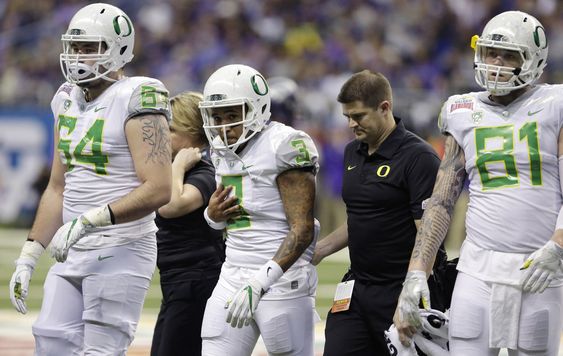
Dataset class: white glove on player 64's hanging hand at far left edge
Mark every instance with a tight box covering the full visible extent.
[10,241,45,314]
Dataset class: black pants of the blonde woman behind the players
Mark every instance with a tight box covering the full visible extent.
[151,266,220,356]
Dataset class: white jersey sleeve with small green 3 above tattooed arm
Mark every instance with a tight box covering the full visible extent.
[276,130,319,174]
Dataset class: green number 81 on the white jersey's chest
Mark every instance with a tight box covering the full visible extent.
[475,122,542,190]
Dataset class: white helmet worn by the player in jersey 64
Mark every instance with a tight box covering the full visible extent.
[60,3,135,84]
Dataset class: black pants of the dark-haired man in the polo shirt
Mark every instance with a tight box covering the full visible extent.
[324,277,402,356]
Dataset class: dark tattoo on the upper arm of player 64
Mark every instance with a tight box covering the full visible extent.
[141,115,171,165]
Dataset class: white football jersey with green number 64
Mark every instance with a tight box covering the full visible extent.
[51,77,170,248]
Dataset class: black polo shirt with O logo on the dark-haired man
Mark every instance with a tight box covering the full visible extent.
[342,118,440,284]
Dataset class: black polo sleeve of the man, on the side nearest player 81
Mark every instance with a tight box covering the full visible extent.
[407,152,440,219]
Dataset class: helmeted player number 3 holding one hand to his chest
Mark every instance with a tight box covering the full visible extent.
[200,64,318,356]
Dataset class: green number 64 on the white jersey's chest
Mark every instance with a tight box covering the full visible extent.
[58,115,109,175]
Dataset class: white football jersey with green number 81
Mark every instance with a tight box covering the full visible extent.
[440,85,563,253]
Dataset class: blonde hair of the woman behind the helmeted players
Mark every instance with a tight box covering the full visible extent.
[170,91,207,143]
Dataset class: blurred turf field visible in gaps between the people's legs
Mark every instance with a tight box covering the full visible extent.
[0,228,563,356]
